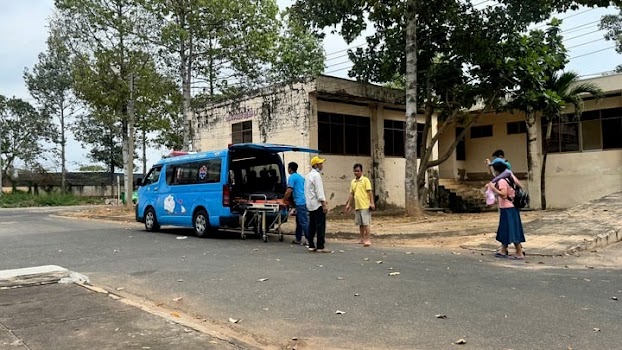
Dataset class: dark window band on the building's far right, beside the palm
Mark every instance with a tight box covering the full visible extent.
[542,108,622,153]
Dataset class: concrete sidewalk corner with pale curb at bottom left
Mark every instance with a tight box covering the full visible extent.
[0,266,263,350]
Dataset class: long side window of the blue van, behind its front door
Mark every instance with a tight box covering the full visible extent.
[166,159,222,186]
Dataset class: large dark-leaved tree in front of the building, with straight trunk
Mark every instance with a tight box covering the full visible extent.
[294,0,620,215]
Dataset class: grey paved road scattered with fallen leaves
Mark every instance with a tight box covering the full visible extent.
[0,209,622,349]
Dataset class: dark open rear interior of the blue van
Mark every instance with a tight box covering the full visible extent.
[229,151,286,199]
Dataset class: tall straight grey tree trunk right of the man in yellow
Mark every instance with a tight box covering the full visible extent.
[404,0,423,216]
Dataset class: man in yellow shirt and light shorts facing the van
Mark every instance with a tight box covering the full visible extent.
[346,163,376,247]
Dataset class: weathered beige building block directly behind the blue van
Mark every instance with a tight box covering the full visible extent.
[194,76,436,207]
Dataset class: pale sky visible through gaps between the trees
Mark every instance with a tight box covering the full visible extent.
[0,0,622,171]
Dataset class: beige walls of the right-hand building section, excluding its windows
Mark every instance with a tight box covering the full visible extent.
[439,74,622,208]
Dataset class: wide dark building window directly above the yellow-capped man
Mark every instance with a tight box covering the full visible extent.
[317,112,371,156]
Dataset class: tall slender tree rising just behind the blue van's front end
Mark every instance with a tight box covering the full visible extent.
[55,0,179,205]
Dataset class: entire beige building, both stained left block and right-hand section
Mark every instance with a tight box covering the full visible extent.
[194,74,622,208]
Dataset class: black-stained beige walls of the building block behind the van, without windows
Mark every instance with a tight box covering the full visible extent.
[194,77,438,208]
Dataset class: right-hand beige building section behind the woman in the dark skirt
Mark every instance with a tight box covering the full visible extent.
[439,74,622,208]
